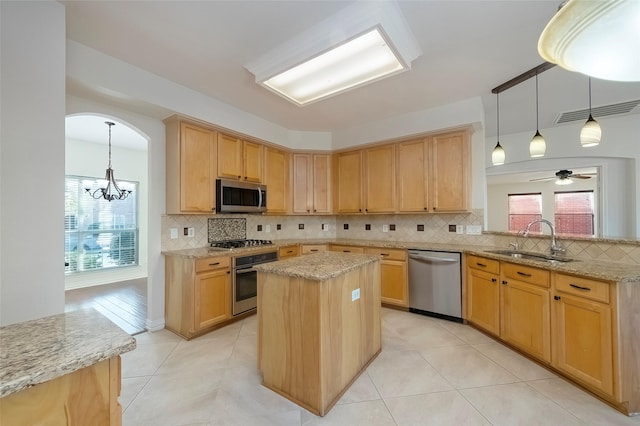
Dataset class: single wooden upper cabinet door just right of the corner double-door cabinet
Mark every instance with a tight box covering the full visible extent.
[333,149,364,213]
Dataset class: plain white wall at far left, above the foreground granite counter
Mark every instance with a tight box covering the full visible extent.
[0,1,65,325]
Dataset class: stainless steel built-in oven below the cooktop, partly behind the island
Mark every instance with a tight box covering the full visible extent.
[232,251,278,315]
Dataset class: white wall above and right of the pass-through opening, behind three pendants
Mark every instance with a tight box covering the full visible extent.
[485,114,640,238]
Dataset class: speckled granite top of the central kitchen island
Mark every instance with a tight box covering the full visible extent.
[254,252,380,281]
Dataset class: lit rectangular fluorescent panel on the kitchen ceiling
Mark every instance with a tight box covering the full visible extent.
[262,28,406,105]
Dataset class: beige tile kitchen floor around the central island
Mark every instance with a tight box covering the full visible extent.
[120,309,640,426]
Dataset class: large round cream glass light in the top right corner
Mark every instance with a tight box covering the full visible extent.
[538,0,640,81]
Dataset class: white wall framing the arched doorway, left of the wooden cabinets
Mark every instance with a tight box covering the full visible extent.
[67,96,165,330]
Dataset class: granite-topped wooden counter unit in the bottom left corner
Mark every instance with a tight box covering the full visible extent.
[0,309,136,425]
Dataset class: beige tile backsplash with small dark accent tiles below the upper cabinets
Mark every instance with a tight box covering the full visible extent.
[162,209,640,264]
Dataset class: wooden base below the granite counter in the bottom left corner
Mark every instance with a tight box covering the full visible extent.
[0,356,122,426]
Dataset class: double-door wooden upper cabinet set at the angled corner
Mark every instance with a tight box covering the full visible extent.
[290,154,331,214]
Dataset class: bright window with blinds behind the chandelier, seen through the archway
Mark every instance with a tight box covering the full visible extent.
[64,176,138,274]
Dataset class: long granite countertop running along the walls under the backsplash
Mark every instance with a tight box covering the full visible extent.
[164,239,640,283]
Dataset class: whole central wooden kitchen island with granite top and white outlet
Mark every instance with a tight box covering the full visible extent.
[255,252,381,416]
